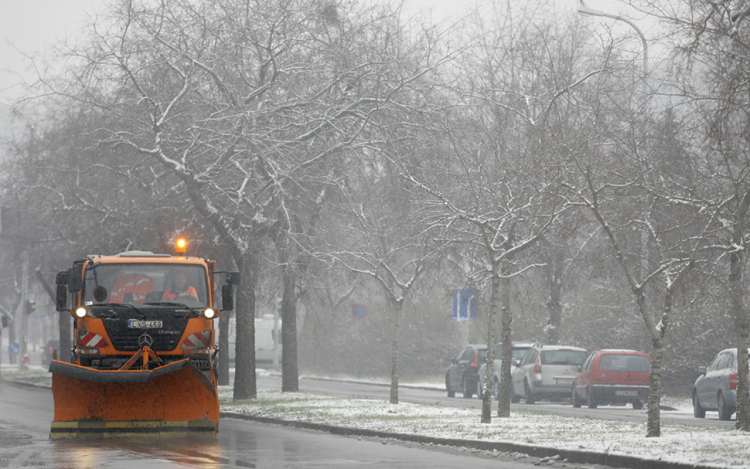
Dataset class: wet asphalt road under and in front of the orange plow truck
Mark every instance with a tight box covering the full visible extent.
[0,382,575,469]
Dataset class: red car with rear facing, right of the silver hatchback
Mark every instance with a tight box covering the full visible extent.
[571,350,651,409]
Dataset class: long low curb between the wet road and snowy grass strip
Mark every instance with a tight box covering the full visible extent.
[220,412,719,469]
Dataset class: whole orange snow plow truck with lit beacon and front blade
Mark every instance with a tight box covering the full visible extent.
[49,240,239,439]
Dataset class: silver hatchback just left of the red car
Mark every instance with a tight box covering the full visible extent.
[511,345,588,404]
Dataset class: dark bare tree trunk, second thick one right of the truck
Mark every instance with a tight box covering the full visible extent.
[281,264,299,392]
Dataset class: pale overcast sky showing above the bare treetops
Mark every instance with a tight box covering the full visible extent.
[0,0,624,103]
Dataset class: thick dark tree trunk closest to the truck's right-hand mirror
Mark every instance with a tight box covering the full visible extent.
[233,254,258,400]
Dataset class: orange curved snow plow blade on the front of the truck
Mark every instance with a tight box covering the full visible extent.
[50,359,219,439]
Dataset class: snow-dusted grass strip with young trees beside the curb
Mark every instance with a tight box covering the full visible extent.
[219,386,750,469]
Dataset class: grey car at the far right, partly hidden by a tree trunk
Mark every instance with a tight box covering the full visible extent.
[693,348,750,420]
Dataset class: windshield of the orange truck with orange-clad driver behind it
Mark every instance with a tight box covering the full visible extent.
[82,263,208,307]
